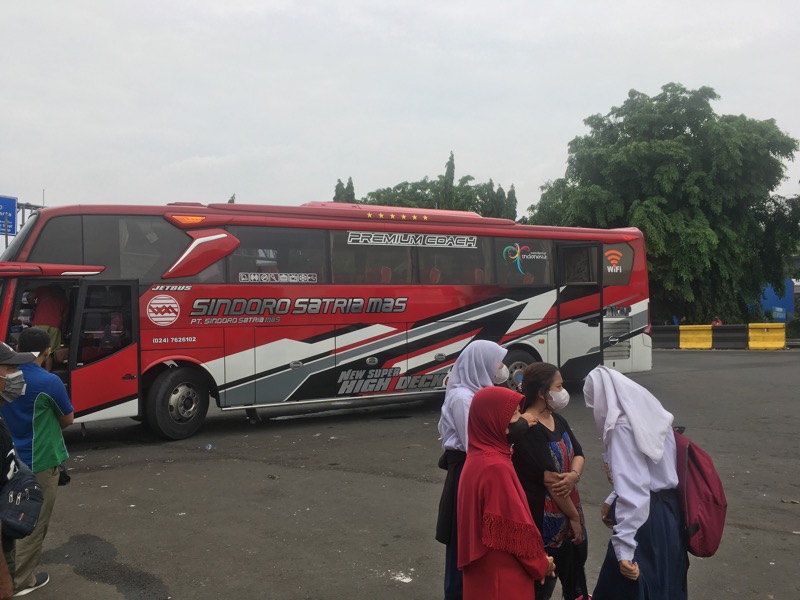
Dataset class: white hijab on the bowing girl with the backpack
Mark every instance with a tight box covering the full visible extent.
[583,366,673,463]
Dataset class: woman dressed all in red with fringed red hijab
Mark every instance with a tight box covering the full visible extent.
[458,387,553,600]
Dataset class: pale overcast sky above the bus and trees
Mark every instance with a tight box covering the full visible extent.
[0,0,800,215]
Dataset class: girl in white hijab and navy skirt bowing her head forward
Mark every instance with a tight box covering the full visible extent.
[583,367,689,600]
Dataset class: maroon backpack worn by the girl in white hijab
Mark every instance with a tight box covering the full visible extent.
[675,431,728,557]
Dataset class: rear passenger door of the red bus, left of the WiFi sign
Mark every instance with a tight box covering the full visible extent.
[548,241,603,381]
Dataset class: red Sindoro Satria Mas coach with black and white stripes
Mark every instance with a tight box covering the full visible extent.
[0,202,652,439]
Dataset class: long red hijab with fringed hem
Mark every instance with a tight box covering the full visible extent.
[458,387,547,577]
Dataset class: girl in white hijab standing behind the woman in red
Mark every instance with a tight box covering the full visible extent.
[436,340,508,600]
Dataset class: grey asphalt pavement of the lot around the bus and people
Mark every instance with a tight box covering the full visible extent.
[29,350,800,600]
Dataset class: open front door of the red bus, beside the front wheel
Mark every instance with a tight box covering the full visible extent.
[69,280,139,422]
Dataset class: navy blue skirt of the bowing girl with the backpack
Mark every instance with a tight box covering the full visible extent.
[592,490,689,600]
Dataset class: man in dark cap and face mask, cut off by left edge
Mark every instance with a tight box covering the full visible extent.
[0,342,36,600]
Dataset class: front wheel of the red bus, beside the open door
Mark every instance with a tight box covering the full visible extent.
[145,368,209,440]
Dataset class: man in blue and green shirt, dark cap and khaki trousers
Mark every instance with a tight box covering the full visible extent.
[0,327,73,596]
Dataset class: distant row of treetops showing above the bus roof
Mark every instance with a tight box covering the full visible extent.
[333,152,517,220]
